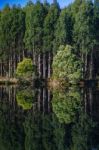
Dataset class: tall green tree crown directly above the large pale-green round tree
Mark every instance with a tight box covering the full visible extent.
[54,8,73,53]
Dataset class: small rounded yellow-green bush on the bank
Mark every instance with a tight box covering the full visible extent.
[16,58,35,79]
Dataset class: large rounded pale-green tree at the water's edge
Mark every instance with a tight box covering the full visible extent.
[52,45,82,83]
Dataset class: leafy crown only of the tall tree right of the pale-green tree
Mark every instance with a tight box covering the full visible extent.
[74,1,95,53]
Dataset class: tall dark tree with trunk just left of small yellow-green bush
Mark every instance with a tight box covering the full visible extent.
[10,6,25,75]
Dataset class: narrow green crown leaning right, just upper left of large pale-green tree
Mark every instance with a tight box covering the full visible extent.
[43,3,60,52]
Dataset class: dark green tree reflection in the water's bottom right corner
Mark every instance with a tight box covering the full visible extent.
[71,113,96,150]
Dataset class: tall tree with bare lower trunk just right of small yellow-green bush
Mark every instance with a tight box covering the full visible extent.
[24,1,46,77]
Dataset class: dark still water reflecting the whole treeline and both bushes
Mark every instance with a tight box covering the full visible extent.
[0,86,99,150]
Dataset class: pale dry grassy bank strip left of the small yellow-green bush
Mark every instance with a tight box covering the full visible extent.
[0,77,18,84]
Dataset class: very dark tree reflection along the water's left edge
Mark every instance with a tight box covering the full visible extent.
[0,87,24,150]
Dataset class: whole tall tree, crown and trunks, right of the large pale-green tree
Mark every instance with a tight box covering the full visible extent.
[74,0,95,78]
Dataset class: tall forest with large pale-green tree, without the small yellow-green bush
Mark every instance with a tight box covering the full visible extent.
[0,0,99,81]
